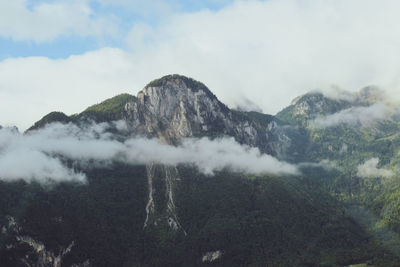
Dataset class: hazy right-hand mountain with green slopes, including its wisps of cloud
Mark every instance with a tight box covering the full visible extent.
[277,87,400,264]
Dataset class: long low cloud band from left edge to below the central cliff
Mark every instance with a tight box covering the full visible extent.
[0,122,297,182]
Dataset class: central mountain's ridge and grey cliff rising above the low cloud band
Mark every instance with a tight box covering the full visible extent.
[28,75,286,155]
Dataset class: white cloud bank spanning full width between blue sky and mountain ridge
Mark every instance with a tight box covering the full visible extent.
[0,0,400,128]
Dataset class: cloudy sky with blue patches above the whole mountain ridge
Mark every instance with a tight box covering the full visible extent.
[0,0,400,130]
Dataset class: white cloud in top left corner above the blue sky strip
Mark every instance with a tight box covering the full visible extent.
[0,0,115,42]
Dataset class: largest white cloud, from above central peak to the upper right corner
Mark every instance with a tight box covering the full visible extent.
[124,0,400,113]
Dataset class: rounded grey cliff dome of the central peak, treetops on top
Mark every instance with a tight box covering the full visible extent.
[126,75,231,141]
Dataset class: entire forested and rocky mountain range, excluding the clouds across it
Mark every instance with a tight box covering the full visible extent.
[0,75,400,266]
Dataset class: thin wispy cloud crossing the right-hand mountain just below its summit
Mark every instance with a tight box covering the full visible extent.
[311,103,391,128]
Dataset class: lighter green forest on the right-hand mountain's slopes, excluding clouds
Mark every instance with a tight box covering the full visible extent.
[279,93,400,266]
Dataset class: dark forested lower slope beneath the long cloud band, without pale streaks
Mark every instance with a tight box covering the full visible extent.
[0,164,391,266]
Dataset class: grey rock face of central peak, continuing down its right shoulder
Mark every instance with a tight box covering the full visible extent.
[125,75,284,154]
